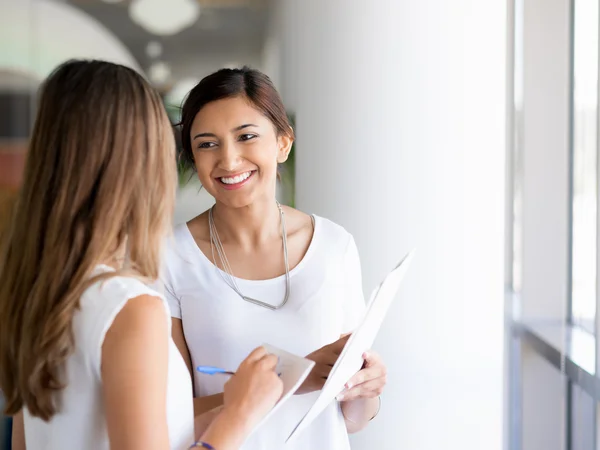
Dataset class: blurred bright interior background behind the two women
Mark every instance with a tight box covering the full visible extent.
[0,0,600,450]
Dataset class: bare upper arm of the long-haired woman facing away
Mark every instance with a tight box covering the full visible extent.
[101,295,169,450]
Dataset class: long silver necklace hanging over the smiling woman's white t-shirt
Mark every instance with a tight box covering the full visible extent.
[208,202,291,311]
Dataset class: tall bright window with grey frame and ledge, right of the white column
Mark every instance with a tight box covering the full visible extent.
[507,0,600,450]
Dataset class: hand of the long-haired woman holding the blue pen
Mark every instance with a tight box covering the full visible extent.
[223,347,283,429]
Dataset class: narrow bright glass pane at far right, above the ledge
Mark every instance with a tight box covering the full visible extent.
[571,0,598,331]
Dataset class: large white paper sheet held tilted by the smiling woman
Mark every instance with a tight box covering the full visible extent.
[287,251,414,442]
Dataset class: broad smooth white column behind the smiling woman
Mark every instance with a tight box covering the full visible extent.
[280,0,506,450]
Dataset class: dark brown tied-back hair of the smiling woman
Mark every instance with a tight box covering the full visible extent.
[179,66,294,168]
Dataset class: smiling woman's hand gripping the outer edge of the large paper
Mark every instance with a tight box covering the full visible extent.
[337,350,387,402]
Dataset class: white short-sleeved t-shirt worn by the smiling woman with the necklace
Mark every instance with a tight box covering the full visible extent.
[164,217,365,450]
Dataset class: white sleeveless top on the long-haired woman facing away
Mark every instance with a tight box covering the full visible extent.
[24,266,194,450]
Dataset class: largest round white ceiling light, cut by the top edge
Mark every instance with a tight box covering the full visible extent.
[129,0,200,36]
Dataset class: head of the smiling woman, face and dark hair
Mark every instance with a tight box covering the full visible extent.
[181,68,294,206]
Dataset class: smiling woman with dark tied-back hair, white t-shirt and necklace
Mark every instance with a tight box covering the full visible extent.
[164,68,386,450]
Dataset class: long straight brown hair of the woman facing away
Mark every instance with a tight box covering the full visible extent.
[0,61,176,420]
